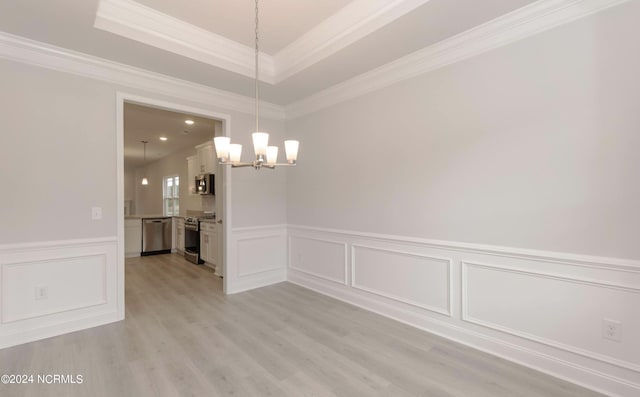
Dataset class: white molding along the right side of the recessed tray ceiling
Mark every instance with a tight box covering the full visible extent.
[274,0,430,82]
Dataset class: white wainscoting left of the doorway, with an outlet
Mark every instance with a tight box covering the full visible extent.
[0,237,124,348]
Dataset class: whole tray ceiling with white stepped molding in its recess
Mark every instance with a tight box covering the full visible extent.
[0,0,556,105]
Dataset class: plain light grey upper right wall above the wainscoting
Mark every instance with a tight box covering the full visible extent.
[287,2,640,259]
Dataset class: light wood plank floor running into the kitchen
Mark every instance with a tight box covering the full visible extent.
[0,255,599,397]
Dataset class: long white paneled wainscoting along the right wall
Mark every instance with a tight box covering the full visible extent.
[287,226,640,396]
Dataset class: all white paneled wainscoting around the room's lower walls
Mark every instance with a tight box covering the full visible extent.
[0,225,640,396]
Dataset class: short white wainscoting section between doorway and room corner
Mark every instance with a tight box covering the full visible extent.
[225,225,287,294]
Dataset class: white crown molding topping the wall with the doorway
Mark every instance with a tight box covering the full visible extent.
[0,32,285,120]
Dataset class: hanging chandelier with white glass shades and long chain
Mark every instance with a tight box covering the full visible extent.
[213,0,299,170]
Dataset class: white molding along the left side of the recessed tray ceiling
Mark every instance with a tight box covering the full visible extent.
[93,0,275,84]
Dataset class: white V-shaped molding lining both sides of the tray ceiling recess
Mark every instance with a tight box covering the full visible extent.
[93,0,430,84]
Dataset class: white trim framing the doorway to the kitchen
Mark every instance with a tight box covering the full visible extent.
[116,91,232,319]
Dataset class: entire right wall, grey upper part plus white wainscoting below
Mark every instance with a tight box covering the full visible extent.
[287,2,640,396]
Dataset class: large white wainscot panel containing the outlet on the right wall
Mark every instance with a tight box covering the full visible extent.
[462,262,640,372]
